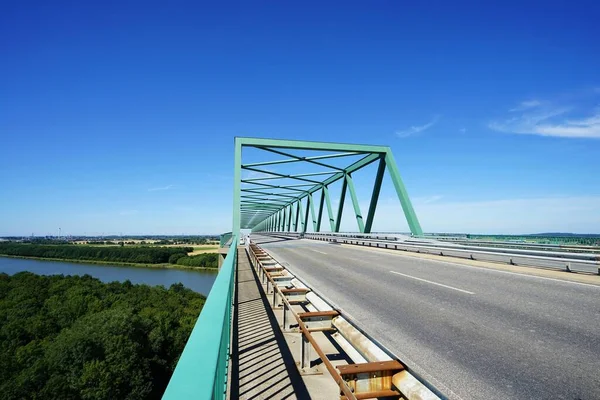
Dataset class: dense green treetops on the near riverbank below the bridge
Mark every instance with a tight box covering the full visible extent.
[0,272,205,399]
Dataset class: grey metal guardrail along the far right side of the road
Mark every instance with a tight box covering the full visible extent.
[304,233,600,274]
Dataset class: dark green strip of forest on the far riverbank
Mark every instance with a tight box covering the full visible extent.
[0,242,194,264]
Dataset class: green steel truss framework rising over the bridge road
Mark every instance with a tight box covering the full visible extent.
[233,137,423,236]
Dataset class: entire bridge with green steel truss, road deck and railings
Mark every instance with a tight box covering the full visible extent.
[163,138,600,400]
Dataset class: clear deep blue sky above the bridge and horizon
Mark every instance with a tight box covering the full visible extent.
[0,1,600,235]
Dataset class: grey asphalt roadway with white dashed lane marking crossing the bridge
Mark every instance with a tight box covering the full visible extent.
[252,235,600,400]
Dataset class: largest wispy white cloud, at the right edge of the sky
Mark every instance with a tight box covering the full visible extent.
[488,100,600,139]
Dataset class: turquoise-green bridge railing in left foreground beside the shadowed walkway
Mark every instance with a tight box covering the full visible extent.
[163,236,239,400]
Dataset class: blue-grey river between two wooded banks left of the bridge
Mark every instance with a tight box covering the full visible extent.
[0,256,217,296]
